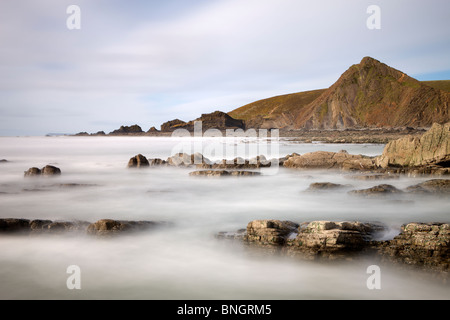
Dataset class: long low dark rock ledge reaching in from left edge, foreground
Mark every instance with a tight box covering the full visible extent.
[0,218,168,236]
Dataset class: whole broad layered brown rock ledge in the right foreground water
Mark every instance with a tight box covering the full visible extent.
[217,220,450,275]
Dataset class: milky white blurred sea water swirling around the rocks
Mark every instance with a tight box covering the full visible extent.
[0,137,450,299]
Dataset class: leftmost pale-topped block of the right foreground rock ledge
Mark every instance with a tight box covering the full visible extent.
[244,220,299,245]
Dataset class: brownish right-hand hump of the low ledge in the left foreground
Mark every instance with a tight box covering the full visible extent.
[87,219,161,236]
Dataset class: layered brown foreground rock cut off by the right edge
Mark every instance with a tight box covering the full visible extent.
[382,223,450,271]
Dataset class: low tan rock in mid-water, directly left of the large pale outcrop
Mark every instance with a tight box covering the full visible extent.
[283,151,375,170]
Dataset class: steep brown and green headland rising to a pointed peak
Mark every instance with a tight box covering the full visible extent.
[229,57,450,129]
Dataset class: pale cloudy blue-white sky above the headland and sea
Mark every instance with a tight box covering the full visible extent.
[0,0,450,135]
